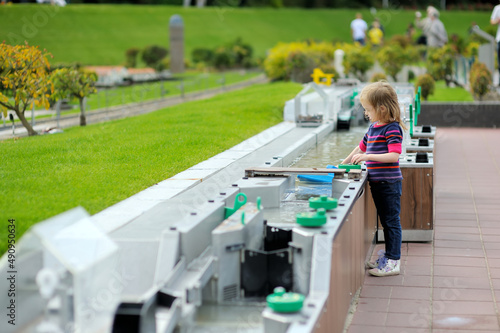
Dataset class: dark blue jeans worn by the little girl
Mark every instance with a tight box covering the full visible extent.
[370,181,403,260]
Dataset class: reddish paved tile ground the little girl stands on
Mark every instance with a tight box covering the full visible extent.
[348,128,500,333]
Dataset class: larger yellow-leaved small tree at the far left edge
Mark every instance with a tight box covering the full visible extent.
[0,42,54,136]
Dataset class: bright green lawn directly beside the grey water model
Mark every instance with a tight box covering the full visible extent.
[0,83,301,253]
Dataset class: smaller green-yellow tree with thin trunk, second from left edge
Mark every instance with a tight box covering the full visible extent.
[52,68,97,126]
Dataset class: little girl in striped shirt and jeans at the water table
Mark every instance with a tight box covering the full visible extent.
[342,82,405,276]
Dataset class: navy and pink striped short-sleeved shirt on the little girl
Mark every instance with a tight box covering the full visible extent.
[359,122,403,182]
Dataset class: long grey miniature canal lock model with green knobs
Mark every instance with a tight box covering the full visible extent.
[0,81,432,333]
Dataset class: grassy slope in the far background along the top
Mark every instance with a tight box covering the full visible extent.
[0,5,491,65]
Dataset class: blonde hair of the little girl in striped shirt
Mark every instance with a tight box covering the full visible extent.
[359,81,406,130]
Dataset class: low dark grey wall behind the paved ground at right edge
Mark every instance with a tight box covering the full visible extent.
[418,102,500,128]
